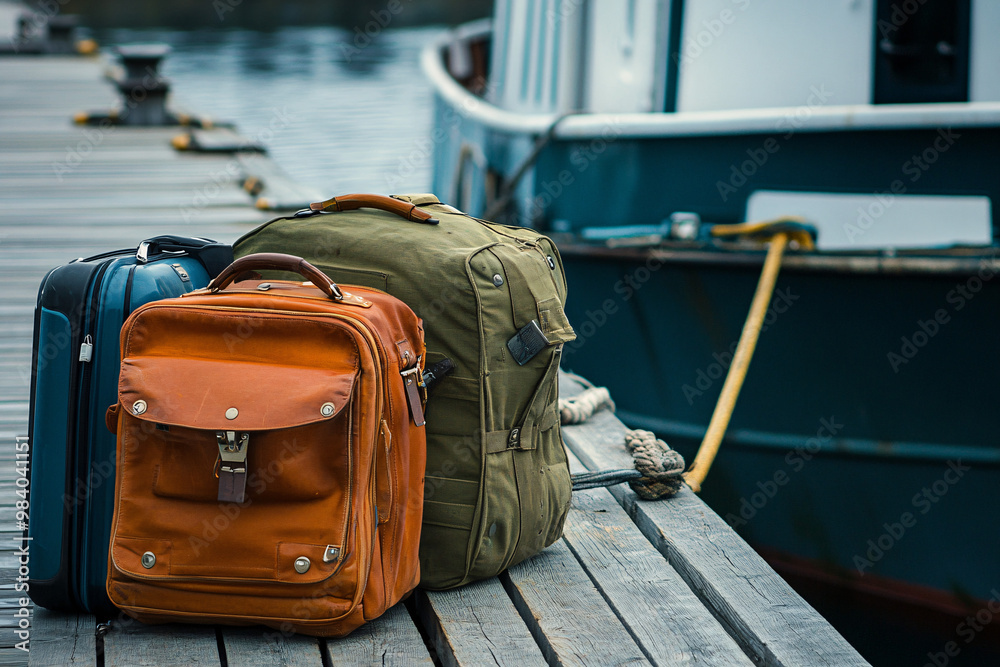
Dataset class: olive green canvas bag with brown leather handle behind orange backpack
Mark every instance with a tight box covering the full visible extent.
[234,195,575,589]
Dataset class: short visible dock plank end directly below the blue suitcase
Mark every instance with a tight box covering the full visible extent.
[27,607,97,667]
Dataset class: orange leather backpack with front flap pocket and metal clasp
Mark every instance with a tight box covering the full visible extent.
[108,254,426,636]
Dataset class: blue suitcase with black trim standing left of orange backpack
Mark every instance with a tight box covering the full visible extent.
[27,236,233,615]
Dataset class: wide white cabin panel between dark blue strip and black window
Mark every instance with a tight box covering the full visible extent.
[677,0,875,111]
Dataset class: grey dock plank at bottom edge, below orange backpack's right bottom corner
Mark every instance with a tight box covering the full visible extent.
[325,604,433,666]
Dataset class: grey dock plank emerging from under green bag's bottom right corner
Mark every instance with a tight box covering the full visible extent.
[500,540,650,665]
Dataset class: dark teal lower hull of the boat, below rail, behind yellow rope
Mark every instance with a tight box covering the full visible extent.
[563,246,1000,611]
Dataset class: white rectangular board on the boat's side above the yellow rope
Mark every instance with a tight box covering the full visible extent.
[746,190,992,250]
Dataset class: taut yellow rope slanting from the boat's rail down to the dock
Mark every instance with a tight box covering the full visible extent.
[684,229,792,493]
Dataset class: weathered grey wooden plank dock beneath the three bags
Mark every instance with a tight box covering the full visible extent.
[0,47,866,667]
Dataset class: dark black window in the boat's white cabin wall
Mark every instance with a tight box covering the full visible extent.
[873,0,970,104]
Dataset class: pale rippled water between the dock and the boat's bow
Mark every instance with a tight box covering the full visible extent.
[99,27,443,196]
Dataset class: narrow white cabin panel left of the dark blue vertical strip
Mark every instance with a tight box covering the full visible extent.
[584,0,668,113]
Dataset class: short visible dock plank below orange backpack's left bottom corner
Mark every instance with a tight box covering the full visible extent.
[104,617,222,667]
